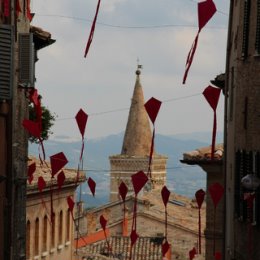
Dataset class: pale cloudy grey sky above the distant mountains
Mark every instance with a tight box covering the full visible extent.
[31,0,229,140]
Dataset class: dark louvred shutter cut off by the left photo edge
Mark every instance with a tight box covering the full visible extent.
[0,25,13,100]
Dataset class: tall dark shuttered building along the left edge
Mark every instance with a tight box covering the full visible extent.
[0,0,39,260]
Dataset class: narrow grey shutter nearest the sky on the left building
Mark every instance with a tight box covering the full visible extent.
[19,33,35,87]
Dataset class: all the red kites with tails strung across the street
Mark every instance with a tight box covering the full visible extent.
[22,0,224,260]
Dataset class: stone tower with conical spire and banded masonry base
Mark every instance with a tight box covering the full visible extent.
[109,66,167,201]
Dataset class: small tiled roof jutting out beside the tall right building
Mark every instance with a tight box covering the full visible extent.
[181,144,224,164]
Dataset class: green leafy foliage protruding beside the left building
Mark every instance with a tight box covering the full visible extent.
[29,104,57,143]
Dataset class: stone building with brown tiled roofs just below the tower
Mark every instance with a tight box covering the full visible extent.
[78,190,206,260]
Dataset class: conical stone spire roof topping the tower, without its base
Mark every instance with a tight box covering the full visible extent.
[121,69,152,156]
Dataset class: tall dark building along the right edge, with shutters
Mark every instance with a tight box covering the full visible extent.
[225,0,260,260]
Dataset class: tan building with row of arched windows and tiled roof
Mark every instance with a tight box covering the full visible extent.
[26,157,85,260]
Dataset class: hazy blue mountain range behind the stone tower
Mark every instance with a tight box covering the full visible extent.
[29,132,223,207]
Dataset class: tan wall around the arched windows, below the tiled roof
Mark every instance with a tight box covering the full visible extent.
[26,189,74,260]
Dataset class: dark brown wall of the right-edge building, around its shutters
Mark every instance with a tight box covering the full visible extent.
[225,1,260,260]
